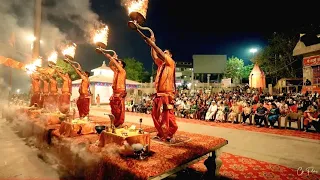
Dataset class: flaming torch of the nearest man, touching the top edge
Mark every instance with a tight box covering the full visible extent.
[125,0,154,39]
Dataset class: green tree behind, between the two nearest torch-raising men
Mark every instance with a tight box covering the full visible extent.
[123,58,150,82]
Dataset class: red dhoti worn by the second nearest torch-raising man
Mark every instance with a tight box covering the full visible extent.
[110,92,126,127]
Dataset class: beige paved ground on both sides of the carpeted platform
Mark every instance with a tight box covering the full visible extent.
[0,107,320,180]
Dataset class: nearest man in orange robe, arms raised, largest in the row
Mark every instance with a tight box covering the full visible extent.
[145,37,178,142]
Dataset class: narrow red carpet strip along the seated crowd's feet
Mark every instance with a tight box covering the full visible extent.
[126,112,320,140]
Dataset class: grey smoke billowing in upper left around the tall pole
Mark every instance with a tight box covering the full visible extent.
[0,0,99,92]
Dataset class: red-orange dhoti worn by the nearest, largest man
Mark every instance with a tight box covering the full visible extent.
[151,96,178,139]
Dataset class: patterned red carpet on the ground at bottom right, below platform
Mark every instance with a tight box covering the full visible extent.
[190,153,320,180]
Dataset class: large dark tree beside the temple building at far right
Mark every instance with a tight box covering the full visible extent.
[252,33,302,82]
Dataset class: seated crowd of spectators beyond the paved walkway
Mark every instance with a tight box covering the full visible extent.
[126,88,320,132]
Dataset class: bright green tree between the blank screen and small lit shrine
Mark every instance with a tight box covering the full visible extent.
[224,56,253,80]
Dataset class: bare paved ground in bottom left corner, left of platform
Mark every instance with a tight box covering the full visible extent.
[0,118,59,180]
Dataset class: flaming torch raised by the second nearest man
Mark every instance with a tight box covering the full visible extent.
[93,25,117,57]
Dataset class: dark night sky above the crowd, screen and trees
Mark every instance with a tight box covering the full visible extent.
[77,0,315,70]
